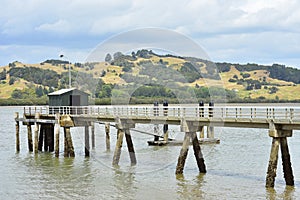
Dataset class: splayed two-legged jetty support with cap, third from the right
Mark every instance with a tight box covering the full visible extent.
[112,119,136,165]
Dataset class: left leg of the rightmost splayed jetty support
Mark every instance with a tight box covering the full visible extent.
[266,137,280,187]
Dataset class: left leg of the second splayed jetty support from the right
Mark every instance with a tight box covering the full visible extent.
[175,132,191,174]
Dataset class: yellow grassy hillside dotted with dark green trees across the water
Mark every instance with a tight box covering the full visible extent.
[0,50,300,105]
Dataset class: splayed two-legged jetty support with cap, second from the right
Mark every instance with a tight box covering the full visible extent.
[176,120,206,174]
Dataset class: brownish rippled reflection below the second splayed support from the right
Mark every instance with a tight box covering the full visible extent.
[176,173,205,199]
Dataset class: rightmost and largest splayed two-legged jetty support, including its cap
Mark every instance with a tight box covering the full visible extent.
[266,120,294,187]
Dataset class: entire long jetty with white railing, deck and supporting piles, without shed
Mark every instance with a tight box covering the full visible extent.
[15,106,300,187]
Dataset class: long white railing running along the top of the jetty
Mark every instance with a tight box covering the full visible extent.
[24,106,300,120]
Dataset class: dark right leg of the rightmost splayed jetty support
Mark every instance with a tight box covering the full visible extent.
[280,137,294,186]
